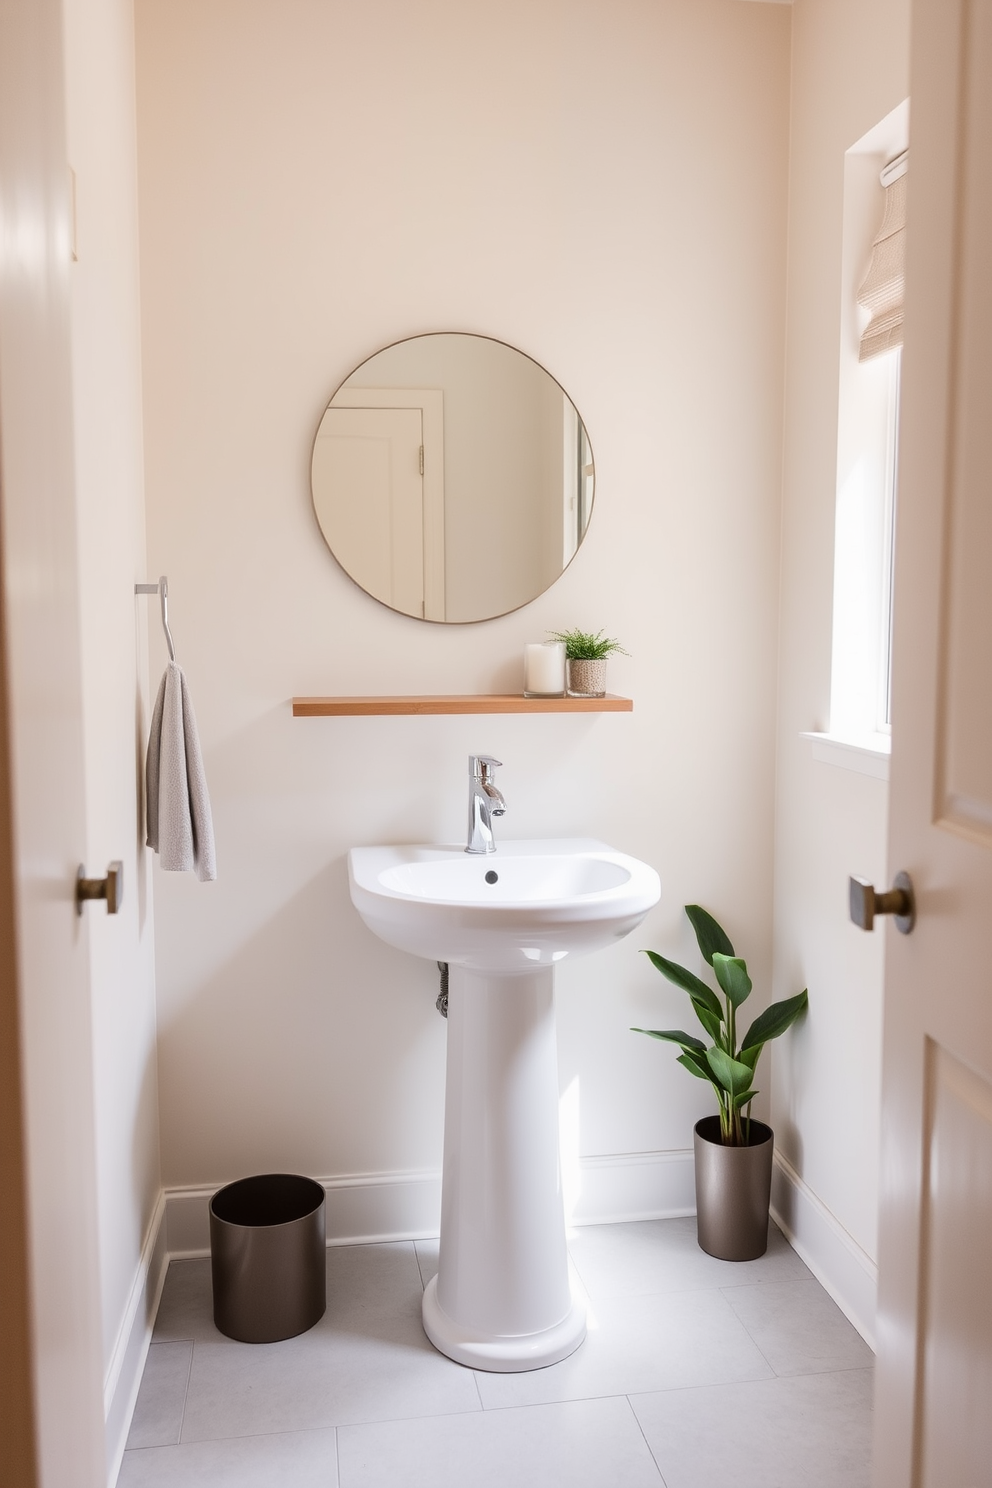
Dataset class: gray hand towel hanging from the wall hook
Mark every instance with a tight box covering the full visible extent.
[144,661,217,882]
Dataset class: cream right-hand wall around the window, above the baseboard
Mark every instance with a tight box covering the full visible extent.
[772,0,909,1335]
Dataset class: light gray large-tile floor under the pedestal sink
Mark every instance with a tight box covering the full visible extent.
[117,1219,872,1488]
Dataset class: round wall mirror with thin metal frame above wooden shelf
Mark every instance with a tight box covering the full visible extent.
[311,333,595,623]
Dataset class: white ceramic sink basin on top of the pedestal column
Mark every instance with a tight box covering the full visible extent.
[348,838,660,973]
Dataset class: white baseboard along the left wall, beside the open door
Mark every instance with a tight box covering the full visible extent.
[103,1193,170,1488]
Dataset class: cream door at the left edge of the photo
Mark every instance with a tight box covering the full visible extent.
[0,0,106,1488]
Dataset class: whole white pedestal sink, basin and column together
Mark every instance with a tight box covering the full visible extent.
[348,838,660,1373]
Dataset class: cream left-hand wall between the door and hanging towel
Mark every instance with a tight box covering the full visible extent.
[64,0,161,1460]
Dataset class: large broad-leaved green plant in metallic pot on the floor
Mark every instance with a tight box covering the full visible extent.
[631,905,809,1260]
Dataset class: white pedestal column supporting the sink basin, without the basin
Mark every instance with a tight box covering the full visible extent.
[424,966,586,1373]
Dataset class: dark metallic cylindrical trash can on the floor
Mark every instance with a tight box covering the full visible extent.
[210,1173,327,1344]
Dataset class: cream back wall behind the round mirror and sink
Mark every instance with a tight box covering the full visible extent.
[137,0,791,1223]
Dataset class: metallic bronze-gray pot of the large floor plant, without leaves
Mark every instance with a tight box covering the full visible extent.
[693,1116,775,1260]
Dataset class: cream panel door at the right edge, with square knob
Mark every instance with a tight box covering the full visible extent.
[875,0,992,1488]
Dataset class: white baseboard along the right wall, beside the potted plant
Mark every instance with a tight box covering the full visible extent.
[772,1152,879,1348]
